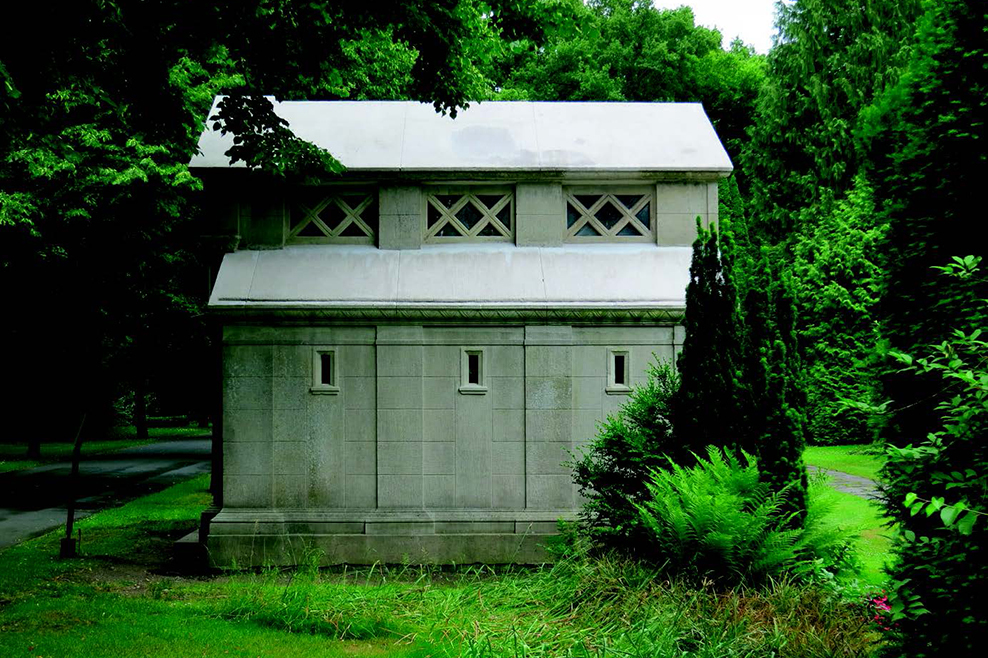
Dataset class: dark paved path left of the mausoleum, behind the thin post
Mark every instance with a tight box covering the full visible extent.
[0,437,211,548]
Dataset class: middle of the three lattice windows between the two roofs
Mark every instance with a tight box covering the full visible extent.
[425,190,515,242]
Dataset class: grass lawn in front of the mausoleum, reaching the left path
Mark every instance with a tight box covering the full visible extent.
[0,477,877,658]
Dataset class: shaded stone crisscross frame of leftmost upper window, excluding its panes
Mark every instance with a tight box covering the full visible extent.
[284,186,381,245]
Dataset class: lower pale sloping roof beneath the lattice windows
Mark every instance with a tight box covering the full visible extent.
[209,244,692,311]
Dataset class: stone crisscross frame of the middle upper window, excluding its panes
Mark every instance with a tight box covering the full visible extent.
[422,185,518,244]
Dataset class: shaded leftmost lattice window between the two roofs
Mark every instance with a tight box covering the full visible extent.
[288,190,378,244]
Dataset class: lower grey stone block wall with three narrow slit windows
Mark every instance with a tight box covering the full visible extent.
[209,325,682,564]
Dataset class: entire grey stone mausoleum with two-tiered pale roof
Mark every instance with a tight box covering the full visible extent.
[192,101,731,565]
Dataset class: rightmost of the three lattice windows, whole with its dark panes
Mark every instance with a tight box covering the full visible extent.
[566,188,655,242]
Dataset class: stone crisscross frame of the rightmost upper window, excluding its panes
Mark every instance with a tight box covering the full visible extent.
[563,185,657,244]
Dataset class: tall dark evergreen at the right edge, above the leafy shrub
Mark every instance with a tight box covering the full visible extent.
[867,0,988,439]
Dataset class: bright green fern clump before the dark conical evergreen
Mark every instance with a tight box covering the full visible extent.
[635,446,847,585]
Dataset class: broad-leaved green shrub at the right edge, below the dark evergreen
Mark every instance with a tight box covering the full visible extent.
[882,257,988,656]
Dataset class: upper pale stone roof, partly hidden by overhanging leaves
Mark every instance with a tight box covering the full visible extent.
[191,99,732,173]
